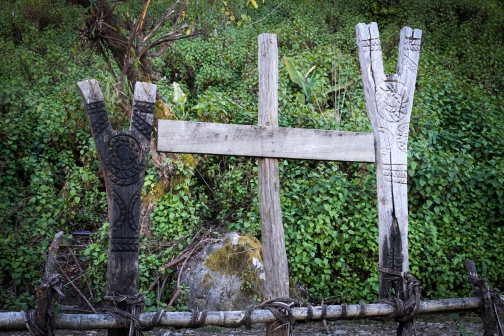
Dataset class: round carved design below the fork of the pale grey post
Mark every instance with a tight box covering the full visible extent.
[376,81,409,122]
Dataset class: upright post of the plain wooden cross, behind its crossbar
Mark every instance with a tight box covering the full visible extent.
[258,34,289,336]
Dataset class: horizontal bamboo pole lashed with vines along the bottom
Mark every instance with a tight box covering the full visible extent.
[0,295,504,330]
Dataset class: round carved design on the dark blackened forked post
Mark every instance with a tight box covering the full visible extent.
[107,134,146,185]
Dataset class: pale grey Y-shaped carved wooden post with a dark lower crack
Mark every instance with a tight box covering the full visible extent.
[356,22,422,335]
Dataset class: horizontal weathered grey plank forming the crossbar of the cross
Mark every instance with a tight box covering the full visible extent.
[157,120,375,162]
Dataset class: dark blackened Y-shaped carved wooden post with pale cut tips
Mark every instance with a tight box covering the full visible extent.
[77,79,156,335]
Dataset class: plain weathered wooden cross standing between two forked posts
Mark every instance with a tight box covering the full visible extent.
[158,34,375,336]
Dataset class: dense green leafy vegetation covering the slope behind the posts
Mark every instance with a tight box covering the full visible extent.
[0,0,504,311]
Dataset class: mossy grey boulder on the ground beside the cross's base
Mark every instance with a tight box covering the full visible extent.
[182,233,264,311]
